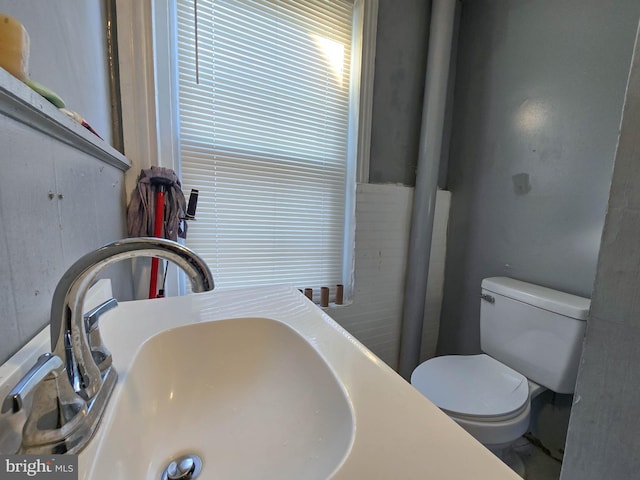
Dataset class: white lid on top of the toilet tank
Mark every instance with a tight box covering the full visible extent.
[482,277,591,320]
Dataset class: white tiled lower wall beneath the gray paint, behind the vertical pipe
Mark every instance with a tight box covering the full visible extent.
[327,184,450,368]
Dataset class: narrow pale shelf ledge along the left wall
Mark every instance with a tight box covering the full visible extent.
[0,68,131,171]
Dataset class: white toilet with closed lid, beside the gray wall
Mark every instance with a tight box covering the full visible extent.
[411,277,590,473]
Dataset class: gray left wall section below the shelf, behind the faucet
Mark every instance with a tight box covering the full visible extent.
[0,120,131,364]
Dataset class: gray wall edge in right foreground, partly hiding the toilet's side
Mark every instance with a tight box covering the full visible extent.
[561,20,640,480]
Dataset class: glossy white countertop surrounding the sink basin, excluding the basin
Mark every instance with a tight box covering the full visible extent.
[0,286,520,480]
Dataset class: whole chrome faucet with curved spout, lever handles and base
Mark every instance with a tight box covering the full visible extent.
[2,237,214,454]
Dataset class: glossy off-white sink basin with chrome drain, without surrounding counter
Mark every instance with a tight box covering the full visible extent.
[89,318,355,480]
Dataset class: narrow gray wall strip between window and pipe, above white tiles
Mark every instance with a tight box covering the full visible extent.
[369,0,431,185]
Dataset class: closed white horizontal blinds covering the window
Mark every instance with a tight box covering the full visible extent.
[176,0,355,293]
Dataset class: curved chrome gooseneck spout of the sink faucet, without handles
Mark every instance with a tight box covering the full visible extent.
[51,237,214,401]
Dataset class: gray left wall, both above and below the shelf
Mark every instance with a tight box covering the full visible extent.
[0,0,131,363]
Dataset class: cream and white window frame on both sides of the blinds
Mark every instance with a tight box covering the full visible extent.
[116,0,378,299]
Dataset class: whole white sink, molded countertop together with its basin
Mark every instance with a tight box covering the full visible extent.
[0,286,521,480]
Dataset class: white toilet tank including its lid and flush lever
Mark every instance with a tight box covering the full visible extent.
[480,277,591,393]
